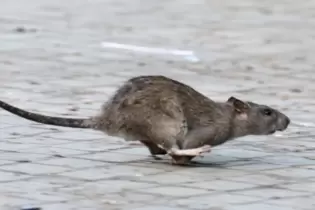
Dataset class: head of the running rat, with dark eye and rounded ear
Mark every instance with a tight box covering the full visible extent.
[227,96,290,135]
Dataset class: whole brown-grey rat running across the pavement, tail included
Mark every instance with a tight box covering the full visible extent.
[0,75,290,165]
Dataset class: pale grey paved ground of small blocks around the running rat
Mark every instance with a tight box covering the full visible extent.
[0,0,315,210]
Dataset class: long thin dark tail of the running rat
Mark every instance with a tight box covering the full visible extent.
[0,100,94,128]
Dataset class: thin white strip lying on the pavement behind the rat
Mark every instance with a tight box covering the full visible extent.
[102,42,200,62]
